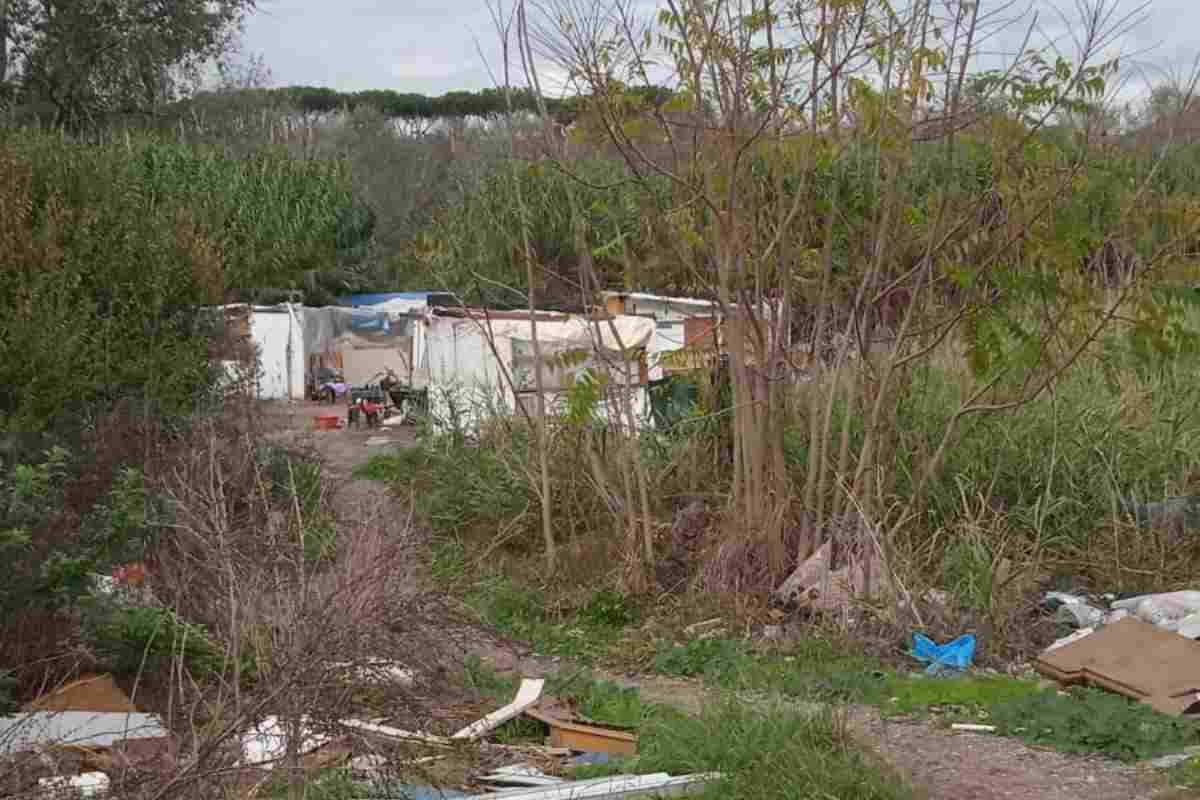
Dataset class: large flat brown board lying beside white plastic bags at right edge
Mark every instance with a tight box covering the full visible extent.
[1033,618,1200,716]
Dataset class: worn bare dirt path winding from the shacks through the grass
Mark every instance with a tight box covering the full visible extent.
[272,403,1180,800]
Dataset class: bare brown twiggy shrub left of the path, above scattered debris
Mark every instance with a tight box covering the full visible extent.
[2,417,456,800]
